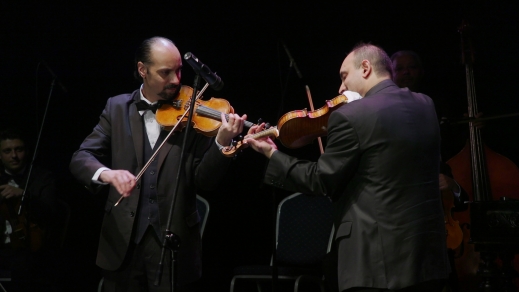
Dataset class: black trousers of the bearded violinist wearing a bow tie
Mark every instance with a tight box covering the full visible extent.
[103,226,196,292]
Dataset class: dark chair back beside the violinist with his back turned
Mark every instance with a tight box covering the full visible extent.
[276,193,333,267]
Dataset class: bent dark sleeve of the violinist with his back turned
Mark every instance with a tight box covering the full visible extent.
[264,112,360,198]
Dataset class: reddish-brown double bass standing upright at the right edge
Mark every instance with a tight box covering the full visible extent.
[447,22,519,291]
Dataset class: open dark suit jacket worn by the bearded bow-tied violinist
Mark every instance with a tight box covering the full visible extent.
[70,90,230,284]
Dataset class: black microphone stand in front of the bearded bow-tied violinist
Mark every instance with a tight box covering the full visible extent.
[153,74,200,292]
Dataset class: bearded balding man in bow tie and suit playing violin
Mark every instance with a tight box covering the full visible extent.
[70,37,246,291]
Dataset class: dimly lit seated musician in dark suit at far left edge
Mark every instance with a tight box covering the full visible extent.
[0,129,60,291]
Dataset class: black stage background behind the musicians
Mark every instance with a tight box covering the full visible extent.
[0,1,519,291]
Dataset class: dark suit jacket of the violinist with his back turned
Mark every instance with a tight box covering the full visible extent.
[265,80,449,291]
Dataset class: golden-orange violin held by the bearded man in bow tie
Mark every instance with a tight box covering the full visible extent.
[155,85,254,137]
